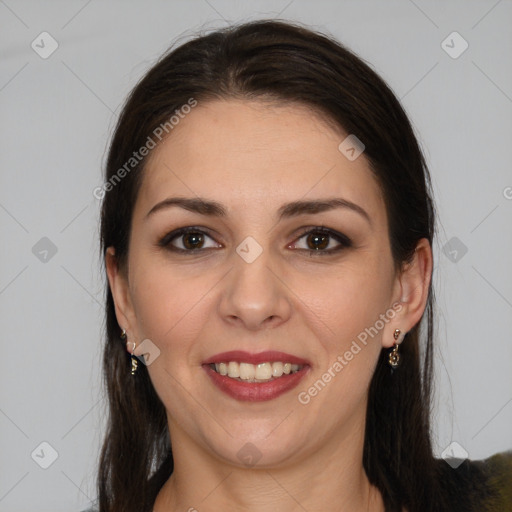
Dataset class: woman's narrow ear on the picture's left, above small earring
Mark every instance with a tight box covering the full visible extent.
[105,246,137,352]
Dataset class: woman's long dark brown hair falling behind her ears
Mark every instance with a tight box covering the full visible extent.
[98,20,492,512]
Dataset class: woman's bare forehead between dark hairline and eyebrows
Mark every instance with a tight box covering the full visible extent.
[136,100,384,221]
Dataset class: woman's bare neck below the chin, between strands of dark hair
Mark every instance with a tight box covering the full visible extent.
[154,416,384,512]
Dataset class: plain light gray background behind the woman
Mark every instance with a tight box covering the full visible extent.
[0,0,512,512]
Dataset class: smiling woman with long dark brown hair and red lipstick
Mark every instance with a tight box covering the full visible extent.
[93,21,512,512]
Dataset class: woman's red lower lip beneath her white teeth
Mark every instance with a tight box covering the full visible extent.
[203,365,309,402]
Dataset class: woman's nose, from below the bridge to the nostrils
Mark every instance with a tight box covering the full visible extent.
[219,243,291,331]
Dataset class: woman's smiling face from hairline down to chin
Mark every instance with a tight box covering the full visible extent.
[109,100,415,467]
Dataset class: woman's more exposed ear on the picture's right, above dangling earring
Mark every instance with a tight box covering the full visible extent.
[382,238,432,348]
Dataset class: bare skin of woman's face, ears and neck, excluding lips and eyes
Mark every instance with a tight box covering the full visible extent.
[106,100,432,512]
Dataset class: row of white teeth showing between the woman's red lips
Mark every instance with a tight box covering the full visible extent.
[209,361,304,382]
